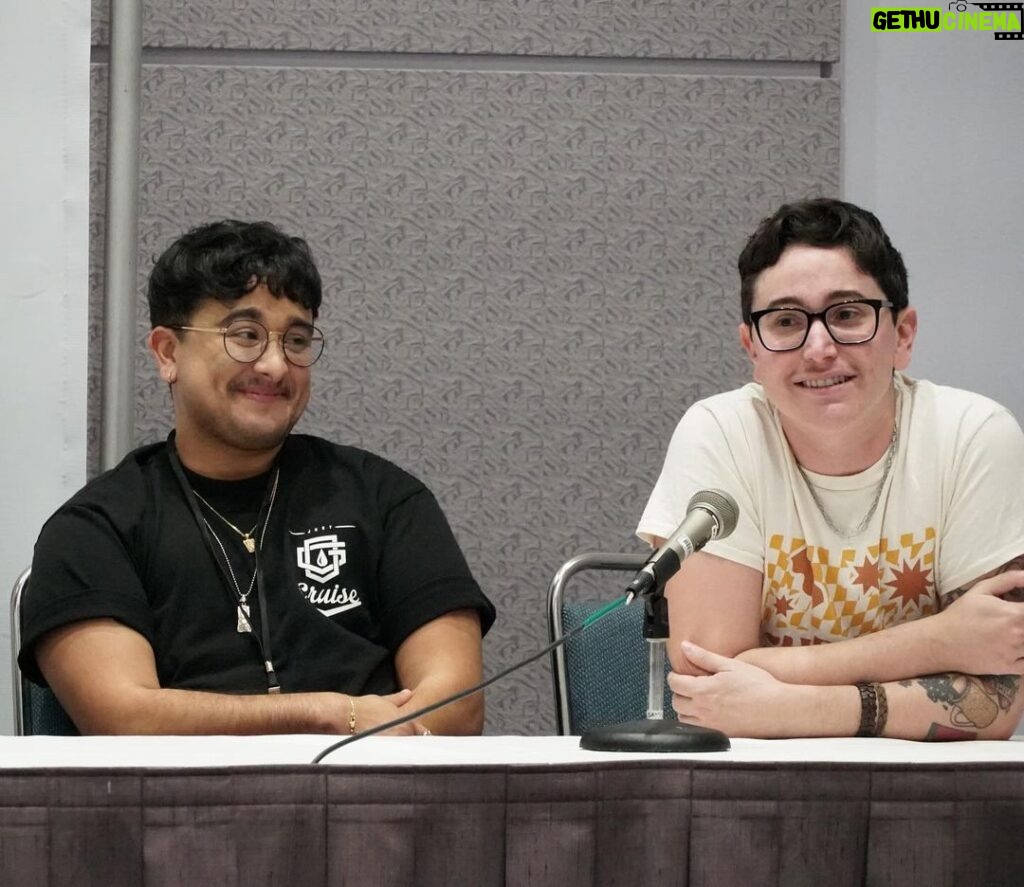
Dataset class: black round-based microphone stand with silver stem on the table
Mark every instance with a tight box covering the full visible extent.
[580,585,730,752]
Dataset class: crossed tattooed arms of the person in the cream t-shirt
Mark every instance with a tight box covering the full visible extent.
[658,543,1024,740]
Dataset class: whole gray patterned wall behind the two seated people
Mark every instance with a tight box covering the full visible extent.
[90,0,840,733]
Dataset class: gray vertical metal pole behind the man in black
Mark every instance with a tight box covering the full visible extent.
[99,0,142,470]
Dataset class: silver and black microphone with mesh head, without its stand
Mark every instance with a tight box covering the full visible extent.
[626,490,739,603]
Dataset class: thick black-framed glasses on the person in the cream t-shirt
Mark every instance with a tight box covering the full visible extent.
[751,299,893,351]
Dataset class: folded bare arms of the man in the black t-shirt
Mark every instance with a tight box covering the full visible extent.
[36,609,483,734]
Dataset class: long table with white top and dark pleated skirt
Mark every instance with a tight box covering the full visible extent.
[0,735,1024,887]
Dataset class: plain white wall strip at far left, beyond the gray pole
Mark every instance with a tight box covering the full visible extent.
[0,0,89,733]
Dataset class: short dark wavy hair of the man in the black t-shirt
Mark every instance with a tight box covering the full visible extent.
[147,219,323,327]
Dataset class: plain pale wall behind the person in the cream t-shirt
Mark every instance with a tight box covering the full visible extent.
[841,2,1024,417]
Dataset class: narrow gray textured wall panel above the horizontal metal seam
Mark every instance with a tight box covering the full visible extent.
[93,0,841,61]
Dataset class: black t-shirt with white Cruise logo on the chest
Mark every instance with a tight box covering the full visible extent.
[18,434,495,694]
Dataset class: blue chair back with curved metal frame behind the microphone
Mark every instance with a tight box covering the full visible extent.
[548,552,672,735]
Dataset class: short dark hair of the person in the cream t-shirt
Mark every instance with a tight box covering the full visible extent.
[736,198,909,324]
